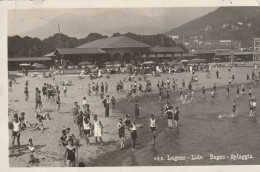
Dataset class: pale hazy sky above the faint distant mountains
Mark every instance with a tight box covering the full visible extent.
[8,7,216,36]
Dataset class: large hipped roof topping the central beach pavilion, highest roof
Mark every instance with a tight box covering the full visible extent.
[77,36,151,49]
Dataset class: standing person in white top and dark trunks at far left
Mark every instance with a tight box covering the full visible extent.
[12,114,21,152]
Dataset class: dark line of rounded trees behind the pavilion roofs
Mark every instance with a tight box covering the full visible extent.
[8,32,187,57]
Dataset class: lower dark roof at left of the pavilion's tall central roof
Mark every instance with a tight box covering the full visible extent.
[54,48,106,54]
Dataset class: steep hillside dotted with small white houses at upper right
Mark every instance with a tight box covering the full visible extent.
[165,7,260,41]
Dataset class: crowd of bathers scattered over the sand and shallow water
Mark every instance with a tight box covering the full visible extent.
[9,63,260,167]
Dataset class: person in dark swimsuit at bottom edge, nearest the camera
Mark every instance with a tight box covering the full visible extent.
[65,139,78,167]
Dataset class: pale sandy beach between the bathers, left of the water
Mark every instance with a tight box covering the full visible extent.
[9,67,253,167]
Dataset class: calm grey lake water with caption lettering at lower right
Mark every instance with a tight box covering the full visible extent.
[90,86,260,166]
